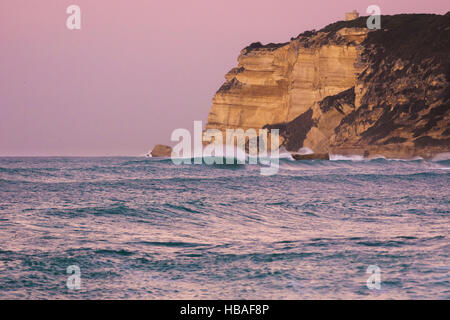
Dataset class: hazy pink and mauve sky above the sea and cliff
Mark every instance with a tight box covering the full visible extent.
[0,0,450,156]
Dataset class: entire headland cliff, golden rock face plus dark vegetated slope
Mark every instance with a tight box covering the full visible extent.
[206,13,450,158]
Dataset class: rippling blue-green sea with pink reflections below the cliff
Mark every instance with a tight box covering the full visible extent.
[0,157,450,299]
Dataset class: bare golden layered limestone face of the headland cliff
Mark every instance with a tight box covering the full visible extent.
[207,28,367,129]
